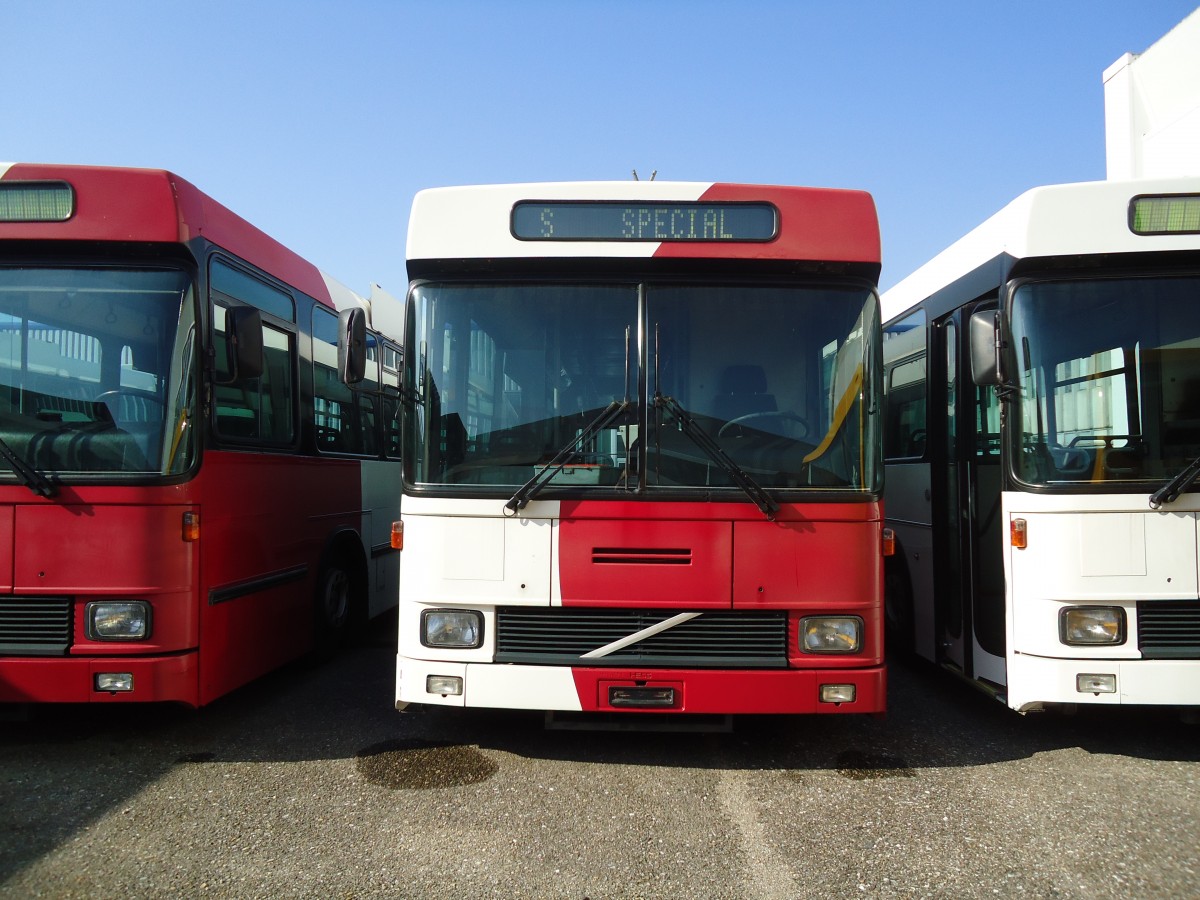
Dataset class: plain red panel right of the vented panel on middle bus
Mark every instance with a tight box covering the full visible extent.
[733,520,883,612]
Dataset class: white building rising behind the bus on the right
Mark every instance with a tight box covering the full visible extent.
[1104,10,1200,180]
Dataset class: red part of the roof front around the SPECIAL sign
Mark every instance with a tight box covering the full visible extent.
[654,184,881,264]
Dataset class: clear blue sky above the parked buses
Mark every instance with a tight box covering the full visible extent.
[0,0,1196,295]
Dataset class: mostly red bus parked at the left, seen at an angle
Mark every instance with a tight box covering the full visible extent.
[0,164,400,707]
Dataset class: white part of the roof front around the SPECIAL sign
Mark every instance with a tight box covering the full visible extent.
[406,181,713,259]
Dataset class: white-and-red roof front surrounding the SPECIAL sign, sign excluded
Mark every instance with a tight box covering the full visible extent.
[407,181,880,276]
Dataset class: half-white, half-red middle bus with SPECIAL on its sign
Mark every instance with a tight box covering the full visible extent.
[396,181,886,721]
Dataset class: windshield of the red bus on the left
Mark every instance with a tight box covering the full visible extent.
[0,266,197,479]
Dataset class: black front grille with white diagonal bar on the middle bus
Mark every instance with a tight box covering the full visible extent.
[496,607,787,668]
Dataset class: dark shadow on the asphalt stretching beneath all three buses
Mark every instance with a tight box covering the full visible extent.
[0,628,1200,889]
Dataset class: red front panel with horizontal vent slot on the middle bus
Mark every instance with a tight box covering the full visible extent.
[558,512,732,608]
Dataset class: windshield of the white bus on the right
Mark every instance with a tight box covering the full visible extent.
[1012,276,1200,490]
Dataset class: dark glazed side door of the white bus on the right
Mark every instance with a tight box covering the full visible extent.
[931,302,1004,680]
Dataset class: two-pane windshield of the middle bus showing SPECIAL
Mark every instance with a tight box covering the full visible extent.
[404,281,881,496]
